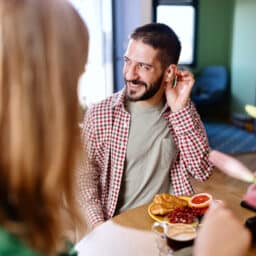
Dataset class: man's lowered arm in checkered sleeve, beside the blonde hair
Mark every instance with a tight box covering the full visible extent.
[76,110,104,228]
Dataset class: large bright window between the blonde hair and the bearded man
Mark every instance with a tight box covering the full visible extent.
[69,0,113,107]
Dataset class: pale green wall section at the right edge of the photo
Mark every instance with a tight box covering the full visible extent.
[231,0,256,112]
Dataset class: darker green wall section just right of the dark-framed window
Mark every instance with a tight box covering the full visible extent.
[194,0,234,72]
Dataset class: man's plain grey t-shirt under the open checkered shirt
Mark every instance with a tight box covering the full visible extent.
[116,102,176,213]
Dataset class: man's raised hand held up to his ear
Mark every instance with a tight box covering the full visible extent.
[165,65,195,112]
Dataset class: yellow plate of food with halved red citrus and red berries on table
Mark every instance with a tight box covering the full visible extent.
[148,193,212,224]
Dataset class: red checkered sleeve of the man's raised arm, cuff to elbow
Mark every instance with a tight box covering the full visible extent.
[170,102,213,181]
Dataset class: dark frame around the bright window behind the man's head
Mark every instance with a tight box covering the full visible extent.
[152,0,199,68]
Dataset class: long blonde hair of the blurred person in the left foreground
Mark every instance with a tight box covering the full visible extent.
[0,0,88,255]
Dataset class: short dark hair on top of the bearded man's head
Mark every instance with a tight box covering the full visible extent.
[130,23,181,68]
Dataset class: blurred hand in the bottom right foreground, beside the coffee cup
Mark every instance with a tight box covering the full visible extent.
[193,204,251,256]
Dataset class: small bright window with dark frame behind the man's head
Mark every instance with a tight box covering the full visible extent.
[153,0,197,66]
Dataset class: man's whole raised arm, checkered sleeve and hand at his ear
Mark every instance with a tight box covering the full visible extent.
[165,68,212,181]
